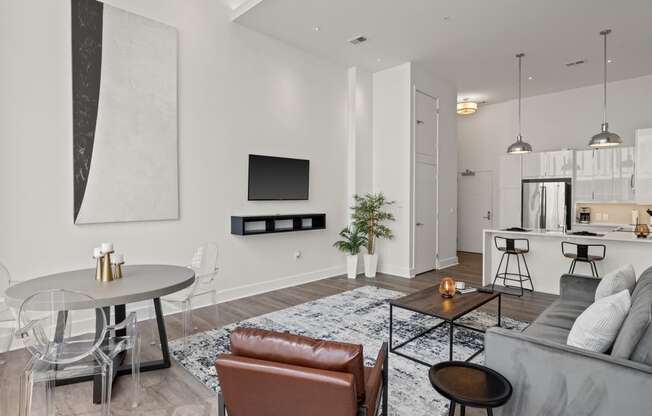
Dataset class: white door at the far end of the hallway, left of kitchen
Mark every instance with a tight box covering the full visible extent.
[457,171,493,253]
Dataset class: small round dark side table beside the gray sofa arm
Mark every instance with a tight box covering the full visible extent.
[428,361,512,416]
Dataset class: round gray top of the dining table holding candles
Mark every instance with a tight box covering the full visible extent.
[5,264,195,309]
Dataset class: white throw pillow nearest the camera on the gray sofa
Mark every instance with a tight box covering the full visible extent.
[566,289,632,352]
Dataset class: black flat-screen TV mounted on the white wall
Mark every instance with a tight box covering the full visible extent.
[249,155,310,201]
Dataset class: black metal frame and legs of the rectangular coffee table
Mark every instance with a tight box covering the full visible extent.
[389,294,502,367]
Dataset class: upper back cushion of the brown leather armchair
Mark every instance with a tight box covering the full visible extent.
[231,328,365,402]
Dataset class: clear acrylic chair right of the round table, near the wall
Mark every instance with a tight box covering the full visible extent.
[161,243,218,343]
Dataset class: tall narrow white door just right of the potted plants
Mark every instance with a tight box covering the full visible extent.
[414,91,438,273]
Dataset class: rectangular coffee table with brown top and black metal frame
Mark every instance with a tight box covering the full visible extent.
[389,286,502,367]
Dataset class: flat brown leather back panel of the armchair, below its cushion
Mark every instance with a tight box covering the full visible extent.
[215,354,358,416]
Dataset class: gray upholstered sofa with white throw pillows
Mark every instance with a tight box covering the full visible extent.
[485,268,652,416]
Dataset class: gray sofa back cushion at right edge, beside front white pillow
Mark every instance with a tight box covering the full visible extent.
[611,268,652,365]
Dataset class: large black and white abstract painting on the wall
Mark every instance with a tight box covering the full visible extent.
[71,0,179,224]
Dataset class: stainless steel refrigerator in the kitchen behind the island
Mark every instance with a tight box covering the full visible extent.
[521,179,571,231]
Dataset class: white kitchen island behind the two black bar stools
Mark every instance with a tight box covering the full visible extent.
[482,230,652,295]
